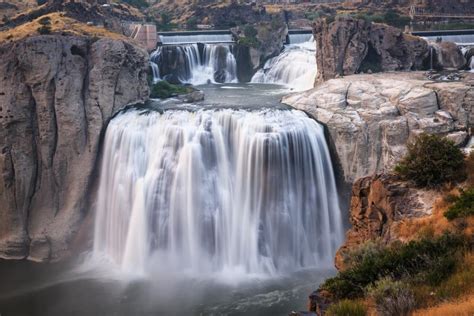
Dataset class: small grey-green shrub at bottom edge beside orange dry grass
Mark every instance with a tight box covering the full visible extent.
[367,278,416,316]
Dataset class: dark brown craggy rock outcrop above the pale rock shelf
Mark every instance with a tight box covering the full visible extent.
[313,17,429,82]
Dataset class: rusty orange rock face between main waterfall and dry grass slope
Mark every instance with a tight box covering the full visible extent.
[335,174,435,269]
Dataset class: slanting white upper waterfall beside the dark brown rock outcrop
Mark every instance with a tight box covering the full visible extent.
[251,38,317,91]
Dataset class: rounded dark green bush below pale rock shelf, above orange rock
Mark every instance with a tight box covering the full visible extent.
[395,134,466,187]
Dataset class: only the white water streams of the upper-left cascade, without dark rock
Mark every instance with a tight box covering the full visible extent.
[151,44,238,85]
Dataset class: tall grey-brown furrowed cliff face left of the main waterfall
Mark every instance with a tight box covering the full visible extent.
[0,36,148,261]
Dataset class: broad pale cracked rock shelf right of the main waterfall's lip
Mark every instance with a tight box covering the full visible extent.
[283,72,474,182]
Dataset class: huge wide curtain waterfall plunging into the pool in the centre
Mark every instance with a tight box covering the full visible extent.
[94,109,343,275]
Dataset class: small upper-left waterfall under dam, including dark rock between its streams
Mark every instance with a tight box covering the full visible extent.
[151,44,238,85]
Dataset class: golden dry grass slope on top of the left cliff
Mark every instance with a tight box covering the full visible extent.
[0,12,128,43]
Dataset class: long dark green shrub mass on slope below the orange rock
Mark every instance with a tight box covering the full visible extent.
[321,233,466,299]
